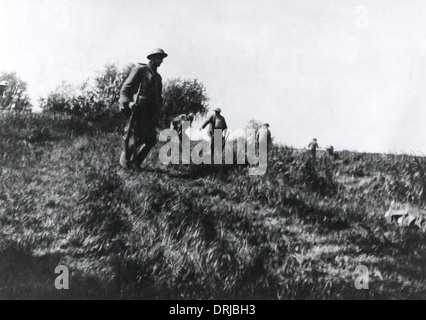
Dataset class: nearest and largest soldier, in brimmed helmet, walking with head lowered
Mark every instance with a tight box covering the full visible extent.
[119,49,167,169]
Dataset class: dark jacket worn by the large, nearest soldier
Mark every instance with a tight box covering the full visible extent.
[119,63,163,124]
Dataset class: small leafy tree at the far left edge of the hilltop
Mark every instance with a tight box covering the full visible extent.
[0,72,32,112]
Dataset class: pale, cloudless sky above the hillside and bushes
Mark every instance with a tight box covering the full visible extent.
[0,0,426,154]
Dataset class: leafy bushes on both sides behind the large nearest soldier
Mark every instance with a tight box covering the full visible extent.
[39,64,208,128]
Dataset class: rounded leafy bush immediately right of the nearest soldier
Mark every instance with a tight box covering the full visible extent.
[161,78,209,128]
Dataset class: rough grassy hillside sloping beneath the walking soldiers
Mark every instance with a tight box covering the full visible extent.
[0,114,426,299]
